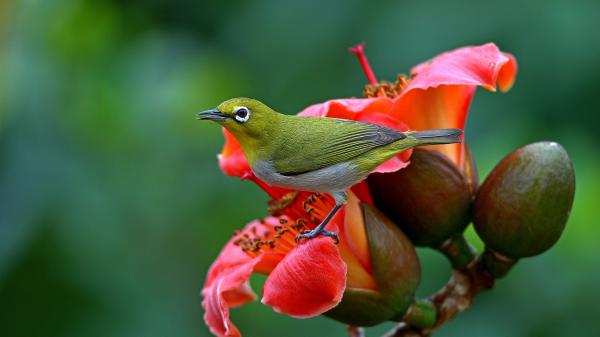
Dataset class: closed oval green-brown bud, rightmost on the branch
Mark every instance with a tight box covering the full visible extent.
[474,142,575,259]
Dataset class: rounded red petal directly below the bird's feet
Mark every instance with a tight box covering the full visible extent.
[262,237,346,318]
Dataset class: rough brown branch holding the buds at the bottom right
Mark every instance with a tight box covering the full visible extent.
[384,258,494,337]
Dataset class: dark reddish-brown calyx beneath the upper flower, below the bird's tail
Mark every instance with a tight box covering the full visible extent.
[368,149,477,247]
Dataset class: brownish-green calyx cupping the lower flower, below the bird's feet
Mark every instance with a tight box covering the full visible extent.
[325,203,421,326]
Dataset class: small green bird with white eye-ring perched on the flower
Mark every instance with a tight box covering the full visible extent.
[197,97,462,242]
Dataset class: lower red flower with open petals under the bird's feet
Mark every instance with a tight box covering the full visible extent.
[202,189,377,336]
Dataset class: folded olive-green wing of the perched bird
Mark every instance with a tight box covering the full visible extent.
[272,117,406,176]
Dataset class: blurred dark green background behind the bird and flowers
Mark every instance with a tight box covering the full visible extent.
[0,0,600,337]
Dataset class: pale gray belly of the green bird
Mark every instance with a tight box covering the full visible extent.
[252,161,365,193]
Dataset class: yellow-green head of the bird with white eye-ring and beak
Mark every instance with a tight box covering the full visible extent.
[197,97,281,143]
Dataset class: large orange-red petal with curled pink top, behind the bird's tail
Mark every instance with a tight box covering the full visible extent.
[392,43,516,167]
